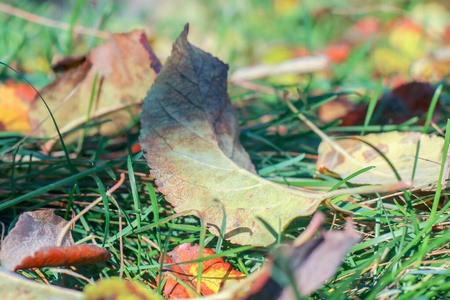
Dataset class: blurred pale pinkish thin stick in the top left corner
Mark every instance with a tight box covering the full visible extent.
[0,3,111,39]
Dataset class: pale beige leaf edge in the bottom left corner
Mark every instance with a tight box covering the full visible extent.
[0,267,85,300]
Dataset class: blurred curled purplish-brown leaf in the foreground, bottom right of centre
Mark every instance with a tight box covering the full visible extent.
[213,213,360,300]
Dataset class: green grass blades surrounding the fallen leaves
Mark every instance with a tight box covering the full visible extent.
[0,0,450,299]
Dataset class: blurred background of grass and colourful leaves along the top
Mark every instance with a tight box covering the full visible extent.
[0,0,450,90]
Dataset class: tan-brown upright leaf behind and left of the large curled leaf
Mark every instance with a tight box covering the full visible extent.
[29,31,156,141]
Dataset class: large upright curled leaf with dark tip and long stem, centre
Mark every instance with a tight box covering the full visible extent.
[140,28,406,245]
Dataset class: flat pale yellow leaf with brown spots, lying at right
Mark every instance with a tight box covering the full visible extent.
[317,132,444,187]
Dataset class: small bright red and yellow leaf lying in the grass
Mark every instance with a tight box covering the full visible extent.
[163,243,245,299]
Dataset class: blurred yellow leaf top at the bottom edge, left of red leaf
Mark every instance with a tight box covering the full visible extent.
[83,277,163,300]
